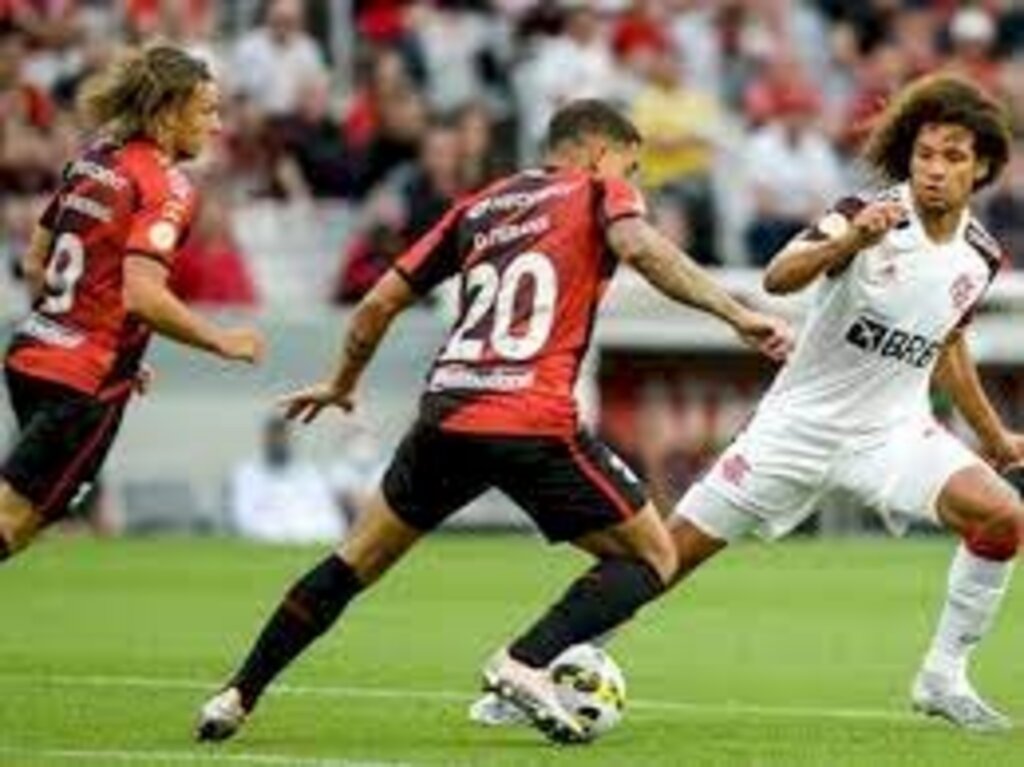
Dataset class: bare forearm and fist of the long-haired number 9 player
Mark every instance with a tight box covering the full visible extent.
[124,253,263,363]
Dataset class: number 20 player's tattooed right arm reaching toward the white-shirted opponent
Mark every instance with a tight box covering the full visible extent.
[607,216,793,358]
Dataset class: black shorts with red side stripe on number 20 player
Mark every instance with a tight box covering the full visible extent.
[383,421,646,542]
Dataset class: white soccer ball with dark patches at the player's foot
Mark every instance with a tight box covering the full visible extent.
[548,644,626,738]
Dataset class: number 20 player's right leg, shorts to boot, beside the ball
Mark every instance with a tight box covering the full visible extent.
[471,434,675,742]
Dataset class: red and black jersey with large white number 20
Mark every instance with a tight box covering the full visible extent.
[395,169,645,436]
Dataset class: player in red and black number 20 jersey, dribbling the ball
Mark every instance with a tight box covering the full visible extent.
[197,100,791,742]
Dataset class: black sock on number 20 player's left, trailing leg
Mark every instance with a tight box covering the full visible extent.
[229,554,362,711]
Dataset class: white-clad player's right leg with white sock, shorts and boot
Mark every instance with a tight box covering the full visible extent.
[856,422,1021,730]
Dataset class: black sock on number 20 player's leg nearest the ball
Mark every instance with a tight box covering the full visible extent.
[509,559,666,669]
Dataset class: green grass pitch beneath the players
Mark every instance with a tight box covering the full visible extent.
[0,536,1024,767]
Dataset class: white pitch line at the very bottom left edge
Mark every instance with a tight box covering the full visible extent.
[0,745,412,767]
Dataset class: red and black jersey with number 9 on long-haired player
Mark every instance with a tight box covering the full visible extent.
[6,140,196,397]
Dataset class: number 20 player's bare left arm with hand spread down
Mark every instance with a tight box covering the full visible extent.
[282,269,417,423]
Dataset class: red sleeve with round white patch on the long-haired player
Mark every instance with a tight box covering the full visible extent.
[125,167,196,267]
